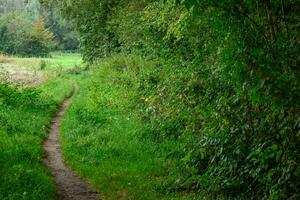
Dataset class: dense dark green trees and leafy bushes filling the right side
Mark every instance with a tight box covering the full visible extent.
[43,0,300,199]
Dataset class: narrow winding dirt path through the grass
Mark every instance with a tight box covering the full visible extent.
[44,88,100,200]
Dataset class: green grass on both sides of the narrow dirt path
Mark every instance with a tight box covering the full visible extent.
[0,53,203,200]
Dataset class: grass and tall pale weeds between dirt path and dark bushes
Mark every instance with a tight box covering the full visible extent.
[62,56,204,200]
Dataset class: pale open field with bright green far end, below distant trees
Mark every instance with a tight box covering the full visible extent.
[0,52,83,87]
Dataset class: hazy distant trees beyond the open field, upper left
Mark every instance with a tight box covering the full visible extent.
[0,0,79,56]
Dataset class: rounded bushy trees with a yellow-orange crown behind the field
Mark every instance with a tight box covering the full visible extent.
[0,13,54,57]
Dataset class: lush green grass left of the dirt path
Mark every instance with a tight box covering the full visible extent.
[0,54,73,200]
